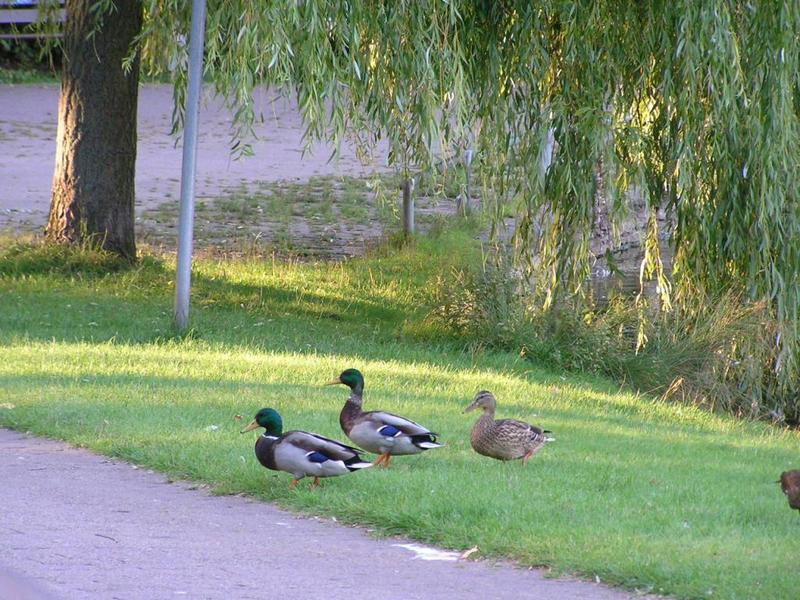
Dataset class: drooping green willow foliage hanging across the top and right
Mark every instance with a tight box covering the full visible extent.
[133,0,800,398]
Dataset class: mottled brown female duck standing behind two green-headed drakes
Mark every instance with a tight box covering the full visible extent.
[464,390,553,465]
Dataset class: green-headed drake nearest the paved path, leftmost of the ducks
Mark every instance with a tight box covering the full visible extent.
[242,408,372,488]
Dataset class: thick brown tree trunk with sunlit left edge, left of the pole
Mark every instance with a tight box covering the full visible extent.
[46,0,142,259]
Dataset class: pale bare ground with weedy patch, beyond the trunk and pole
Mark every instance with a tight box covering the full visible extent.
[0,84,468,257]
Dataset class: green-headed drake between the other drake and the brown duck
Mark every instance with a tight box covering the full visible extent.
[327,369,444,467]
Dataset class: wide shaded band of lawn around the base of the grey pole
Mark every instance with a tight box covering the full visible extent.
[0,237,632,403]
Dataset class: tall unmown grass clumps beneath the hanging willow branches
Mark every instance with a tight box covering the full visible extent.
[419,251,800,425]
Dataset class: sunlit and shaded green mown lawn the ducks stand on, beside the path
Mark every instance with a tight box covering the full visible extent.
[0,231,800,598]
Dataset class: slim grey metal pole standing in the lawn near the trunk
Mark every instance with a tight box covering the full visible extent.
[175,0,206,331]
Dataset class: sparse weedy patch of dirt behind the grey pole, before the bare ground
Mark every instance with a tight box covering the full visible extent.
[137,176,456,258]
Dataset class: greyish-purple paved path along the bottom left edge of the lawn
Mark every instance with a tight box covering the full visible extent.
[0,429,628,600]
